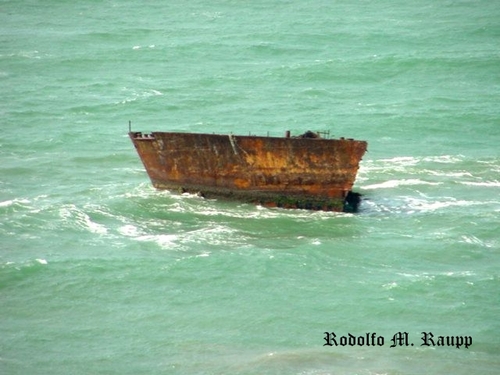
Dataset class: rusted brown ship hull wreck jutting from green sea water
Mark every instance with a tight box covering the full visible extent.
[129,132,367,211]
